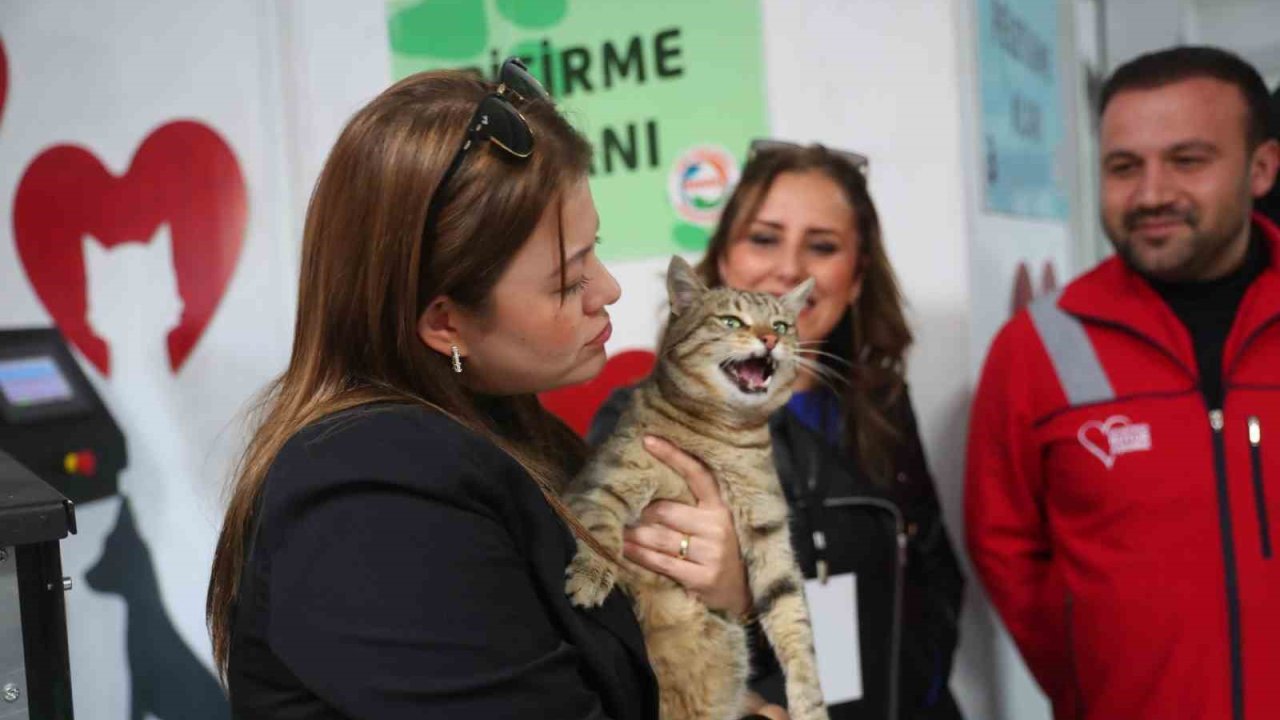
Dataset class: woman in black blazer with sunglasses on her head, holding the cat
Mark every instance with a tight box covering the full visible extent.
[207,60,773,720]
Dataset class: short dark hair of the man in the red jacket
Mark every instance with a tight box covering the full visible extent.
[1098,46,1275,150]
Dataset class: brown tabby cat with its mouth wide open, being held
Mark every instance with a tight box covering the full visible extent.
[566,256,827,720]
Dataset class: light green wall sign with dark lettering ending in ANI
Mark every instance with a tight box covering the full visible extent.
[387,0,768,260]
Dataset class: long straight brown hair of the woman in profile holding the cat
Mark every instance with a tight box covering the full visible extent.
[205,72,608,676]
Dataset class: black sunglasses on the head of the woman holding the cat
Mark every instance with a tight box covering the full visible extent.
[422,58,550,241]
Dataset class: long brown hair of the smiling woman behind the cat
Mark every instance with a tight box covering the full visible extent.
[698,145,911,483]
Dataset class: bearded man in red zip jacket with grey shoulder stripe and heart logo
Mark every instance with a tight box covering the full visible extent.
[965,47,1280,720]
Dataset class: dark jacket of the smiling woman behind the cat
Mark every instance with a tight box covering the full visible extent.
[588,388,964,720]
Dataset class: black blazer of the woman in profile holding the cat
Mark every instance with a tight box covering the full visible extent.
[228,405,658,720]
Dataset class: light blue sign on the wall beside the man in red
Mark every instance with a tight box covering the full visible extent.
[978,0,1069,220]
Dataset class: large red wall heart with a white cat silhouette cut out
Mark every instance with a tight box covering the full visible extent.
[13,120,248,375]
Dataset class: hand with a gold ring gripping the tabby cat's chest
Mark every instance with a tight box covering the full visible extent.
[622,436,751,615]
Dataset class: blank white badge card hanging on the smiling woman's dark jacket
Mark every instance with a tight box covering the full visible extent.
[804,573,863,705]
